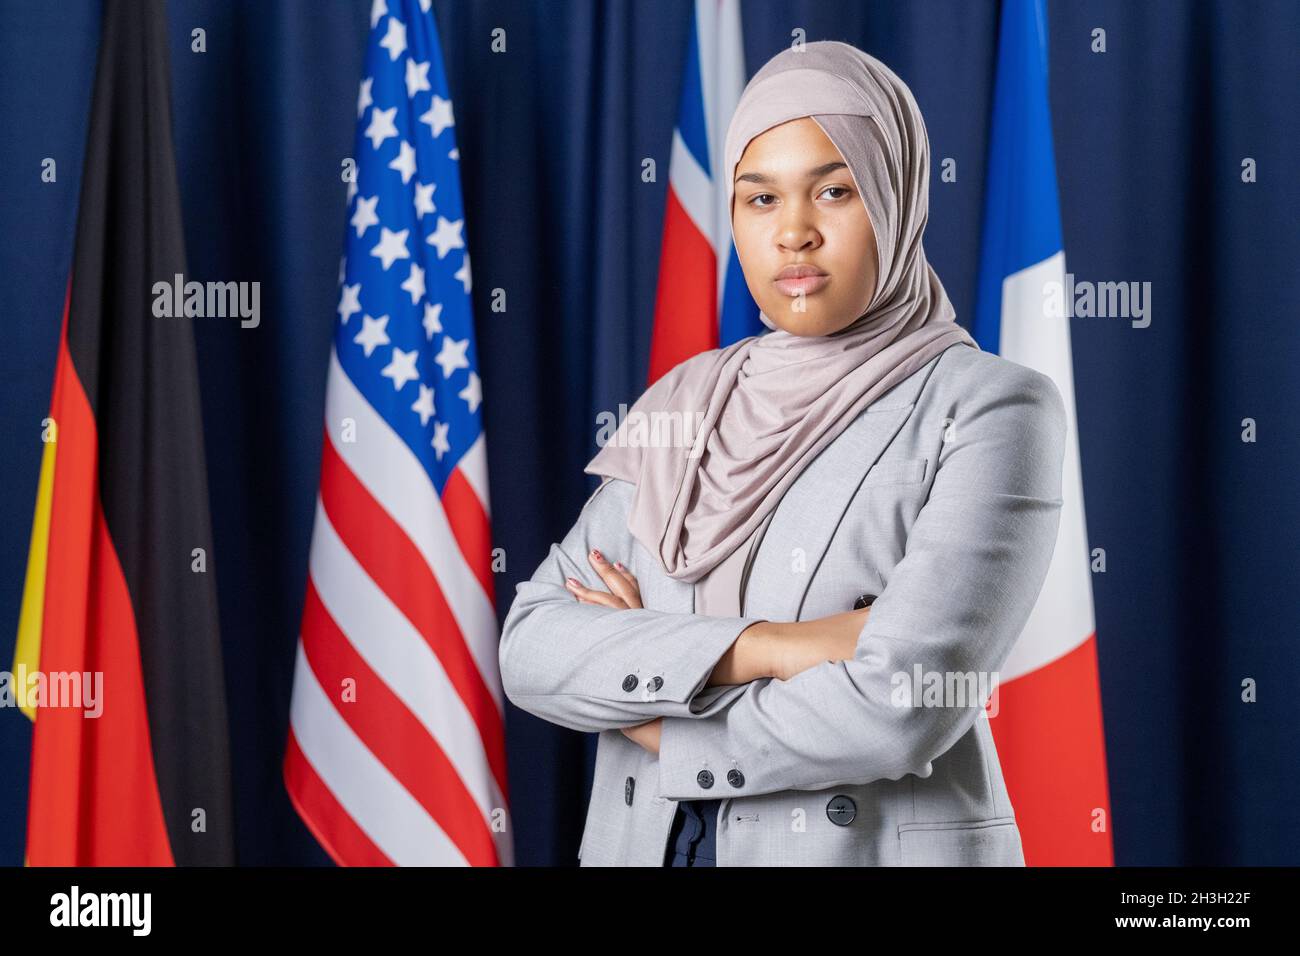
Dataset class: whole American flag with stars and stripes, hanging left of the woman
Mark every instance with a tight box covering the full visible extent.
[283,0,514,866]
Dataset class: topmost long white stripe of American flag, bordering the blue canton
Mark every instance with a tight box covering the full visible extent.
[325,352,504,713]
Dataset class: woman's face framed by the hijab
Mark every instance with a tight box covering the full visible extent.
[732,117,876,336]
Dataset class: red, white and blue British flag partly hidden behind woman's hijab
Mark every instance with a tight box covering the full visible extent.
[649,0,766,384]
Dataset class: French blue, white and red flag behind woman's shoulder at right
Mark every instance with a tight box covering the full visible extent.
[974,0,1114,866]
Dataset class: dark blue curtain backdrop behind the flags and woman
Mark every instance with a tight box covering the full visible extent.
[0,0,1300,865]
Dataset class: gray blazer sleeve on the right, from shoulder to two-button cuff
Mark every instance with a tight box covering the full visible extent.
[658,365,1066,800]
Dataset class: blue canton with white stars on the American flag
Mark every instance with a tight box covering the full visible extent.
[335,3,482,481]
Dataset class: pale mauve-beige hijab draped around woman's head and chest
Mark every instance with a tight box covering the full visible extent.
[584,42,979,581]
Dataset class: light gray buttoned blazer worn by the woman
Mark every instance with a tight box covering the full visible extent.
[501,345,1066,866]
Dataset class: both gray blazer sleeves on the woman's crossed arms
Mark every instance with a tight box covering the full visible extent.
[501,369,1066,800]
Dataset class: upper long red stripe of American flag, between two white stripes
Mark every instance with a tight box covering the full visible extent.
[320,434,507,796]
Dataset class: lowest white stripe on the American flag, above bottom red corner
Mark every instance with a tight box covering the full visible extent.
[290,640,467,866]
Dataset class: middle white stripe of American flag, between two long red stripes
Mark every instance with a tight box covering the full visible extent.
[311,501,506,826]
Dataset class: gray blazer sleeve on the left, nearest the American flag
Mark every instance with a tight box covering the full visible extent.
[499,480,762,732]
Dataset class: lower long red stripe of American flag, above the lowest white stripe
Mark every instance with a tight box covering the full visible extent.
[303,579,499,866]
